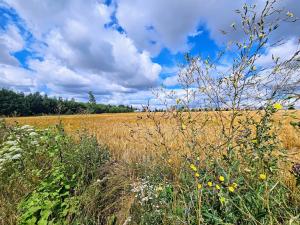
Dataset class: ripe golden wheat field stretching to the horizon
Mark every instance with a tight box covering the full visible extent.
[6,110,300,161]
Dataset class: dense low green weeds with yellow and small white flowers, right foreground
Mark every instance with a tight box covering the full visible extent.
[131,104,300,224]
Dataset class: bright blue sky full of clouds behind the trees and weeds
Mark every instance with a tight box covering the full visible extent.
[0,0,300,106]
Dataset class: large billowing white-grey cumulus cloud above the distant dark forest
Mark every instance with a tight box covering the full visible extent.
[0,0,161,103]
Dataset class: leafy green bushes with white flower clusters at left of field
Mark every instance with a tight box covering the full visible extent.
[0,123,109,224]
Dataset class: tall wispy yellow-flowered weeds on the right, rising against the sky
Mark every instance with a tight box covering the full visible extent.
[126,1,300,224]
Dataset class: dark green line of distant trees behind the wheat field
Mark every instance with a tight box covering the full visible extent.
[0,89,135,116]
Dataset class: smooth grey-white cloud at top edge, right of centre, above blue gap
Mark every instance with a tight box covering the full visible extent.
[116,0,300,54]
